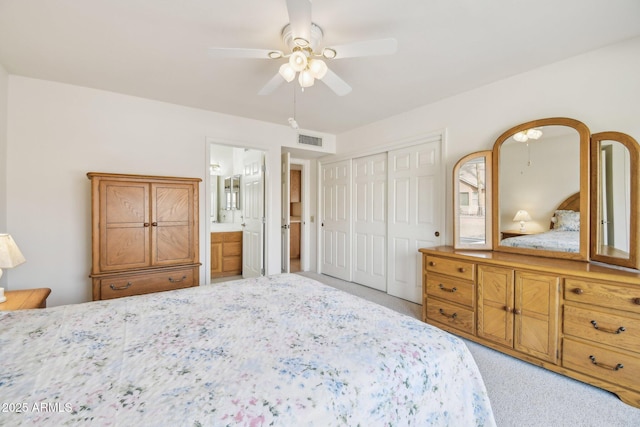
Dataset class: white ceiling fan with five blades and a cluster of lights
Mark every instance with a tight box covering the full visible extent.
[209,0,398,96]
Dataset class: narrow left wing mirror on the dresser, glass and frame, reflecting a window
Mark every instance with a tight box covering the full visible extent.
[453,151,492,249]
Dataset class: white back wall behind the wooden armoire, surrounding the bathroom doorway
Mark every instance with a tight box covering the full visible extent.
[6,75,335,306]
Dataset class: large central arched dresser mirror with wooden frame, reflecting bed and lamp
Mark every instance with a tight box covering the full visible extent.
[493,118,590,261]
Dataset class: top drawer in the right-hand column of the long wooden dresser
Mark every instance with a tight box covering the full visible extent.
[564,278,640,314]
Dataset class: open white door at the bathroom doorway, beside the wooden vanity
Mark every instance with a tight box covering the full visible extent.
[241,150,264,277]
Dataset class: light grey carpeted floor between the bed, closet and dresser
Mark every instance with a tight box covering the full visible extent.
[298,272,640,427]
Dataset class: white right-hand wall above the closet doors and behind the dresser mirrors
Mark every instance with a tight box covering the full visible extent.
[337,38,640,243]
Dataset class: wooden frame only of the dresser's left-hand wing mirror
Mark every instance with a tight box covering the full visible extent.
[453,150,493,250]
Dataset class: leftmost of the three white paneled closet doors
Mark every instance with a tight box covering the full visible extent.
[320,160,351,281]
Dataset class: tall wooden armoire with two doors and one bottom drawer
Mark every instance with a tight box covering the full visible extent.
[87,172,200,300]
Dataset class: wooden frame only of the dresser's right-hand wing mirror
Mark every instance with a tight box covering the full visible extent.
[591,132,640,269]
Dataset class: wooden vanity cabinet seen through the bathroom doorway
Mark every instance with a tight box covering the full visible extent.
[211,231,242,278]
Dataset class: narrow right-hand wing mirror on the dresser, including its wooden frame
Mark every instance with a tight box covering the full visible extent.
[591,132,640,268]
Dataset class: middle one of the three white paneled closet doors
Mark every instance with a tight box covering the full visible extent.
[353,153,387,291]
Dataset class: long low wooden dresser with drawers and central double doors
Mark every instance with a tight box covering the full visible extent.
[420,246,640,407]
